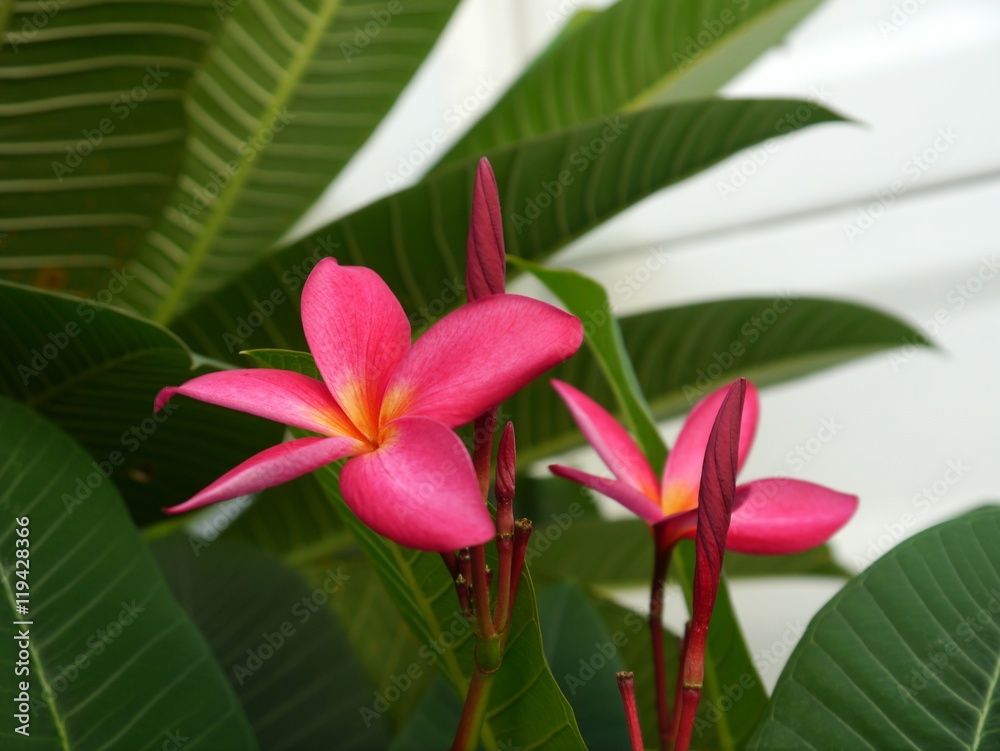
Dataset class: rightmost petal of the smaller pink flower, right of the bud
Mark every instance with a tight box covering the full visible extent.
[726,478,858,555]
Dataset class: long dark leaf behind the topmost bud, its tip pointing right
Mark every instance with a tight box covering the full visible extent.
[173,100,840,360]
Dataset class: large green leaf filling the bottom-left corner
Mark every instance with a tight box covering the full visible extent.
[0,397,256,750]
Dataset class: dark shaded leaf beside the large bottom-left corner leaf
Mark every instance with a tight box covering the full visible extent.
[153,535,389,751]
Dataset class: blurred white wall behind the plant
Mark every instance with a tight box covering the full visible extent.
[290,0,1000,683]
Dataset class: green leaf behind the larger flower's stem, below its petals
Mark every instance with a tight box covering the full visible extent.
[242,350,585,749]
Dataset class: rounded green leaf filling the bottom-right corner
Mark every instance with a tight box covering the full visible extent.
[750,506,1000,751]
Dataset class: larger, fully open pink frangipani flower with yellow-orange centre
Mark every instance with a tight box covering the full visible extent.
[155,258,583,551]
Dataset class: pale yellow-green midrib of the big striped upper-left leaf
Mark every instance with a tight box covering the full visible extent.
[152,0,341,323]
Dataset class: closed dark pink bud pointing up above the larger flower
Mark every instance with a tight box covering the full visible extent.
[465,157,507,302]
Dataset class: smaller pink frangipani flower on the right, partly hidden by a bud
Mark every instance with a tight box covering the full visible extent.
[551,381,858,555]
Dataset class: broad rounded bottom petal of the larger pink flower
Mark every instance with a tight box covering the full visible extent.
[340,417,496,552]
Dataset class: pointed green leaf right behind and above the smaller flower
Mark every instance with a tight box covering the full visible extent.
[506,297,927,468]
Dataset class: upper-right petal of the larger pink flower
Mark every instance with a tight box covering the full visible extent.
[382,295,583,427]
